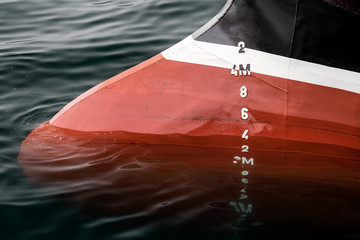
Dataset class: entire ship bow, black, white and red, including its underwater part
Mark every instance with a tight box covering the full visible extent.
[19,0,360,233]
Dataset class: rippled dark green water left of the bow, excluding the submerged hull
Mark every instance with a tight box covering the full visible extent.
[0,0,225,240]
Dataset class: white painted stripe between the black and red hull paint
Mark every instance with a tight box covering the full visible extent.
[162,36,360,94]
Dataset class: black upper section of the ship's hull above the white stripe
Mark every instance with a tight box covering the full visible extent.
[194,0,360,72]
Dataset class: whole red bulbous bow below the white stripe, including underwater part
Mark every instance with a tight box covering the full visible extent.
[18,56,360,233]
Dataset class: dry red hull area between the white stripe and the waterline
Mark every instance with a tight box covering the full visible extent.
[47,56,360,150]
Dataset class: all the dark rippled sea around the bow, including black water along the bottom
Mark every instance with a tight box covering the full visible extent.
[0,0,360,240]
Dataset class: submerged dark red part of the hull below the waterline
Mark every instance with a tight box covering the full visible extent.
[19,123,360,239]
